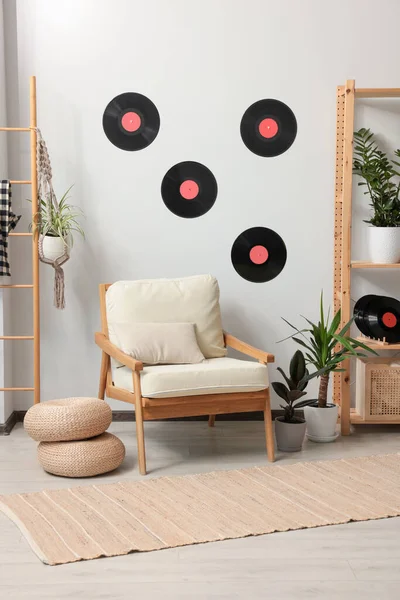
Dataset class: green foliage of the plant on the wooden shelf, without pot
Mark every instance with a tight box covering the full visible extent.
[353,128,400,227]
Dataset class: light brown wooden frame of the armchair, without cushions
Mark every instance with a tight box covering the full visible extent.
[95,283,275,475]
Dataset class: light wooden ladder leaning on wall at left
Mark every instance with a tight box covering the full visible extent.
[0,77,40,404]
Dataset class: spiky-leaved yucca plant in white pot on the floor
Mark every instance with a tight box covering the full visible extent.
[284,292,377,442]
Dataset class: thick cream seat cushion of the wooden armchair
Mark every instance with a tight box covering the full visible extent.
[113,357,268,398]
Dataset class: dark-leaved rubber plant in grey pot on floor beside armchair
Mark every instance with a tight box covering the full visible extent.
[271,350,321,452]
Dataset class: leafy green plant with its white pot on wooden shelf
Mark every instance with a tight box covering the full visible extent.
[353,128,400,264]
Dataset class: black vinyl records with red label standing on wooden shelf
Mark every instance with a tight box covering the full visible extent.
[354,295,400,344]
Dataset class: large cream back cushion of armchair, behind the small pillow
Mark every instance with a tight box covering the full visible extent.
[106,275,226,358]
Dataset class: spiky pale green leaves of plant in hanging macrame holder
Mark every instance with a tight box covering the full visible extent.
[31,186,85,246]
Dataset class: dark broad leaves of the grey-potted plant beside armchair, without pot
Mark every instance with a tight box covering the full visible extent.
[271,350,325,423]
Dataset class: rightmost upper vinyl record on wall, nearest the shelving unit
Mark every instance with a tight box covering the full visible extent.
[240,100,297,156]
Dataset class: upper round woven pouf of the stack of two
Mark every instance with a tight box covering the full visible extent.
[24,398,112,442]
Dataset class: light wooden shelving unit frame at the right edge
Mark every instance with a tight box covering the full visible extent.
[333,79,400,435]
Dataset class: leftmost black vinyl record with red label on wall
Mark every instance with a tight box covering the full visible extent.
[103,92,160,151]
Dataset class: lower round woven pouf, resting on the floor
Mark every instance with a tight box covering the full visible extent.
[38,433,125,477]
